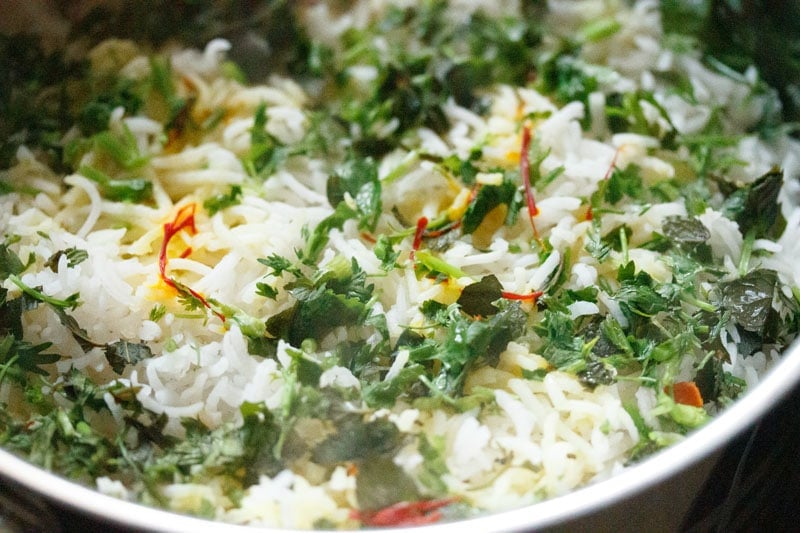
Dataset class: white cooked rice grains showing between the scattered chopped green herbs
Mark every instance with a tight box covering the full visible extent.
[0,1,800,528]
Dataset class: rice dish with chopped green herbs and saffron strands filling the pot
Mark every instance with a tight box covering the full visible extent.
[0,0,800,528]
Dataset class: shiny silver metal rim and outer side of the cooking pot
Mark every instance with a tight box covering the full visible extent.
[0,341,800,533]
